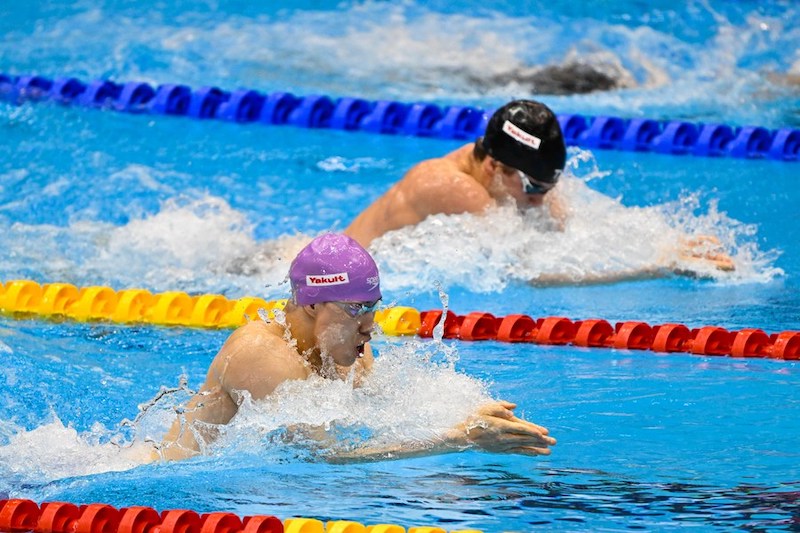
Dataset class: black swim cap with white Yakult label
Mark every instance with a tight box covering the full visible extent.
[479,100,567,183]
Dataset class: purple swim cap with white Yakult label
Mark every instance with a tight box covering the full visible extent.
[289,233,381,305]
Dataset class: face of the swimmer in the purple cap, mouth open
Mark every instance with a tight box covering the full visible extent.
[314,302,377,367]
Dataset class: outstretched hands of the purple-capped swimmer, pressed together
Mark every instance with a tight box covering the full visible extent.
[448,400,556,455]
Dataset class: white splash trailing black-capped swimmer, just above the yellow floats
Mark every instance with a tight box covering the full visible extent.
[92,196,311,298]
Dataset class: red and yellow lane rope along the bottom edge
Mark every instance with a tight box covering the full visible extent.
[0,499,481,533]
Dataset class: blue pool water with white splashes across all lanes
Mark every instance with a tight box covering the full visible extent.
[0,0,800,531]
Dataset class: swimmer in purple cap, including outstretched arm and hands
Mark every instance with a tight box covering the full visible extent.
[153,234,555,460]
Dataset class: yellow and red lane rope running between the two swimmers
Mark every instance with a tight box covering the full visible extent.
[0,280,800,360]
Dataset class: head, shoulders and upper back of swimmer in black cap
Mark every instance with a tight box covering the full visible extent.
[345,100,567,246]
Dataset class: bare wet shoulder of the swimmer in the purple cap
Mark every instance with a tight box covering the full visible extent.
[208,320,308,399]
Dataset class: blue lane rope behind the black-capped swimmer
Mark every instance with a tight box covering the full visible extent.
[0,73,800,161]
